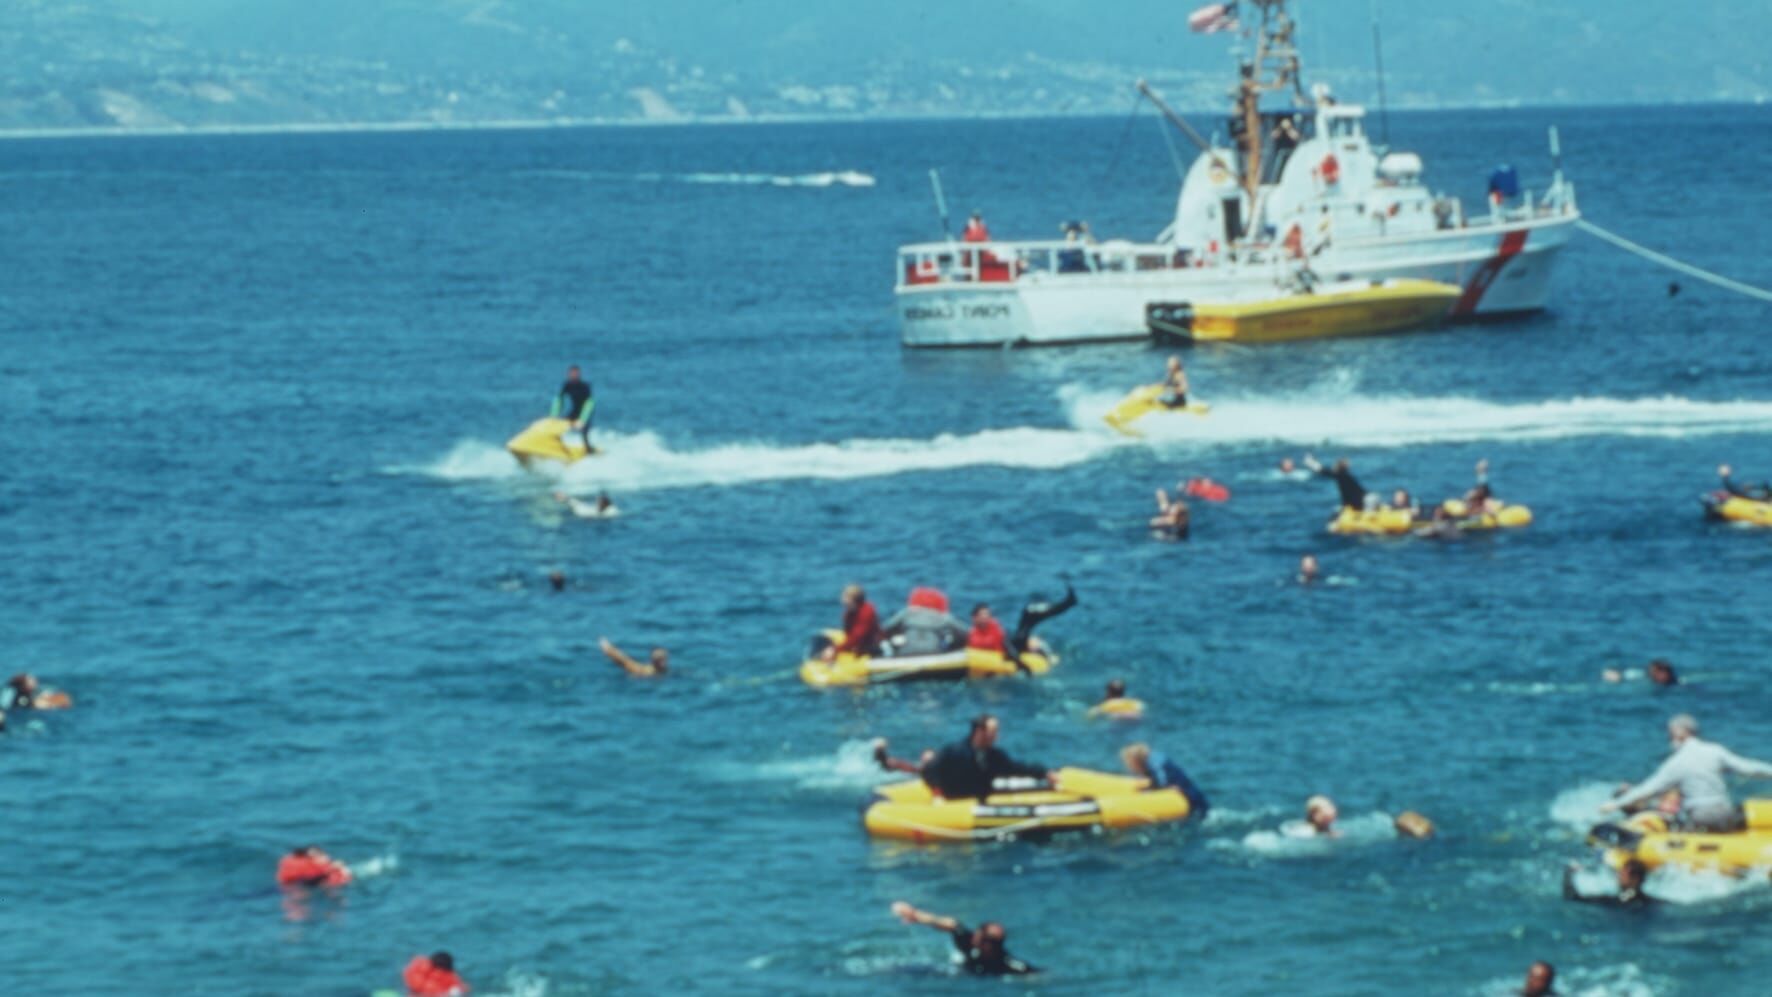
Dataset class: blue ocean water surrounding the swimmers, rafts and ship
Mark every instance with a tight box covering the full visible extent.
[0,108,1772,995]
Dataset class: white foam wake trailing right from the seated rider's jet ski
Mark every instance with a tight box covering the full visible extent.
[1060,390,1772,446]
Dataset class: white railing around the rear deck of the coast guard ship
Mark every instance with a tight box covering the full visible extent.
[898,239,1205,287]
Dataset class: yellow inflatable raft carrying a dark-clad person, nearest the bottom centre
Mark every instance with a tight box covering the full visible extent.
[861,769,1193,843]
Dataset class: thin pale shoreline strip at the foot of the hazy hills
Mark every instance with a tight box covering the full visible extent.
[0,97,1772,142]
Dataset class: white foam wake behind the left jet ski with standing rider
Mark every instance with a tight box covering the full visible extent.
[407,429,1122,494]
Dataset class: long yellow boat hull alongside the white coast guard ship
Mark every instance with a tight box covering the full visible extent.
[1187,278,1464,344]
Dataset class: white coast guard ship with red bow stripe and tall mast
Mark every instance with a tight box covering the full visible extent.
[895,0,1581,347]
